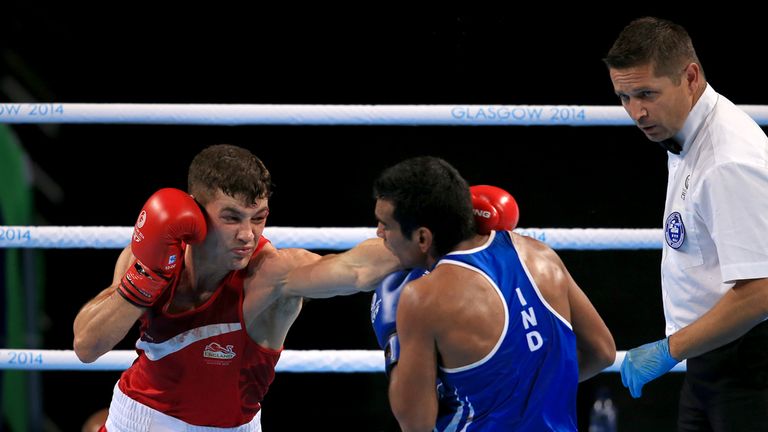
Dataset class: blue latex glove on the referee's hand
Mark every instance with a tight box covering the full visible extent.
[621,338,680,398]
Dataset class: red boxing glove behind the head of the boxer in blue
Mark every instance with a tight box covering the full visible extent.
[469,185,520,234]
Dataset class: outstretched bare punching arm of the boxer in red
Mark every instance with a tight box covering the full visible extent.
[282,238,400,298]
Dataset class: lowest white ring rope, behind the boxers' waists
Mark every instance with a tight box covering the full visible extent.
[0,349,685,373]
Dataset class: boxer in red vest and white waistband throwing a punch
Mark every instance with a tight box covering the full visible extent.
[74,145,399,432]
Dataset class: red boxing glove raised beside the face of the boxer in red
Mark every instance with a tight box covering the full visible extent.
[118,188,207,307]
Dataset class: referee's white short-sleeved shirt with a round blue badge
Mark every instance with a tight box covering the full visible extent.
[661,85,768,336]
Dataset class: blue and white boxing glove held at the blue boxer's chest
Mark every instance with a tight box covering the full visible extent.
[371,268,428,375]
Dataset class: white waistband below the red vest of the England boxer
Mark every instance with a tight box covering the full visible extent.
[106,384,261,432]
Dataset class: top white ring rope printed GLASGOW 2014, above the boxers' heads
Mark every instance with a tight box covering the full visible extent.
[0,102,768,126]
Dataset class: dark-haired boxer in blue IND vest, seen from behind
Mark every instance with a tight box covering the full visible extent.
[372,157,616,432]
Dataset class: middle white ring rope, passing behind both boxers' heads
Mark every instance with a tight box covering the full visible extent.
[0,226,663,250]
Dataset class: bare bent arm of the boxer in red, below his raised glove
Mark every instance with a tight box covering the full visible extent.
[73,248,143,363]
